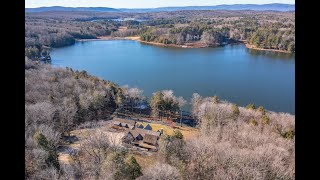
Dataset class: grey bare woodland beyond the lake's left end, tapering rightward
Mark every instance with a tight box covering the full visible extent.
[25,17,119,60]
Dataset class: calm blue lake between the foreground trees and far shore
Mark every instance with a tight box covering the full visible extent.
[51,40,295,114]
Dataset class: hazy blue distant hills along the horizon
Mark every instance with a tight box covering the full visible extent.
[25,3,295,13]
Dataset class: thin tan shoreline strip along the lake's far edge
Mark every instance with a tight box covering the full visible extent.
[76,36,291,54]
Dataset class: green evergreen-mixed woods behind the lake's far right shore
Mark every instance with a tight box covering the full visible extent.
[136,15,295,52]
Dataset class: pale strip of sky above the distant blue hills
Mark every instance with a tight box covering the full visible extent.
[25,0,295,8]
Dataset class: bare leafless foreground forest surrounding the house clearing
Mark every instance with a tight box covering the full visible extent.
[25,57,295,179]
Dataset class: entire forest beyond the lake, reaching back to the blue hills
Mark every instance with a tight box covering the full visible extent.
[25,10,295,59]
